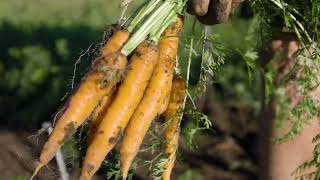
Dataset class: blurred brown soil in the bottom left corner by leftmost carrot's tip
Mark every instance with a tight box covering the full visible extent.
[0,131,57,180]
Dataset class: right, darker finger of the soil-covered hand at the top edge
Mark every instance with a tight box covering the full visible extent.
[198,0,232,25]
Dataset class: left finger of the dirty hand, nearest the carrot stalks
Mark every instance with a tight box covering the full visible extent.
[187,0,210,16]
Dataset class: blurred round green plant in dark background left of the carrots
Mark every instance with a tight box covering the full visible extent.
[6,46,55,98]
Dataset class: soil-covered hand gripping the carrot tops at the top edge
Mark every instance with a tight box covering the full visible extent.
[187,0,243,25]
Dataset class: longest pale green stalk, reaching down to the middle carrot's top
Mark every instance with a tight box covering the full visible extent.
[121,1,175,56]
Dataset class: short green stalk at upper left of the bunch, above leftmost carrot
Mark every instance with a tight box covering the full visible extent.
[127,0,161,32]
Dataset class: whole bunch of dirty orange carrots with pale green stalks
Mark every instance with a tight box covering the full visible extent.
[31,0,186,180]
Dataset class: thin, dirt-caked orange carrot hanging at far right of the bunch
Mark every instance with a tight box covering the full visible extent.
[162,76,186,180]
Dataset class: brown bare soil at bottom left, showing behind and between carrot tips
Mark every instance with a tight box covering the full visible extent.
[0,130,101,180]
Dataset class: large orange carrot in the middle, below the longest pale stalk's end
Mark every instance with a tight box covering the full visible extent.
[80,41,159,180]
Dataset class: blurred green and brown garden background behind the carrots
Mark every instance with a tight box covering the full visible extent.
[0,0,261,180]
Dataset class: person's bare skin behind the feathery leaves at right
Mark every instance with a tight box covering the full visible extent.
[260,33,320,180]
